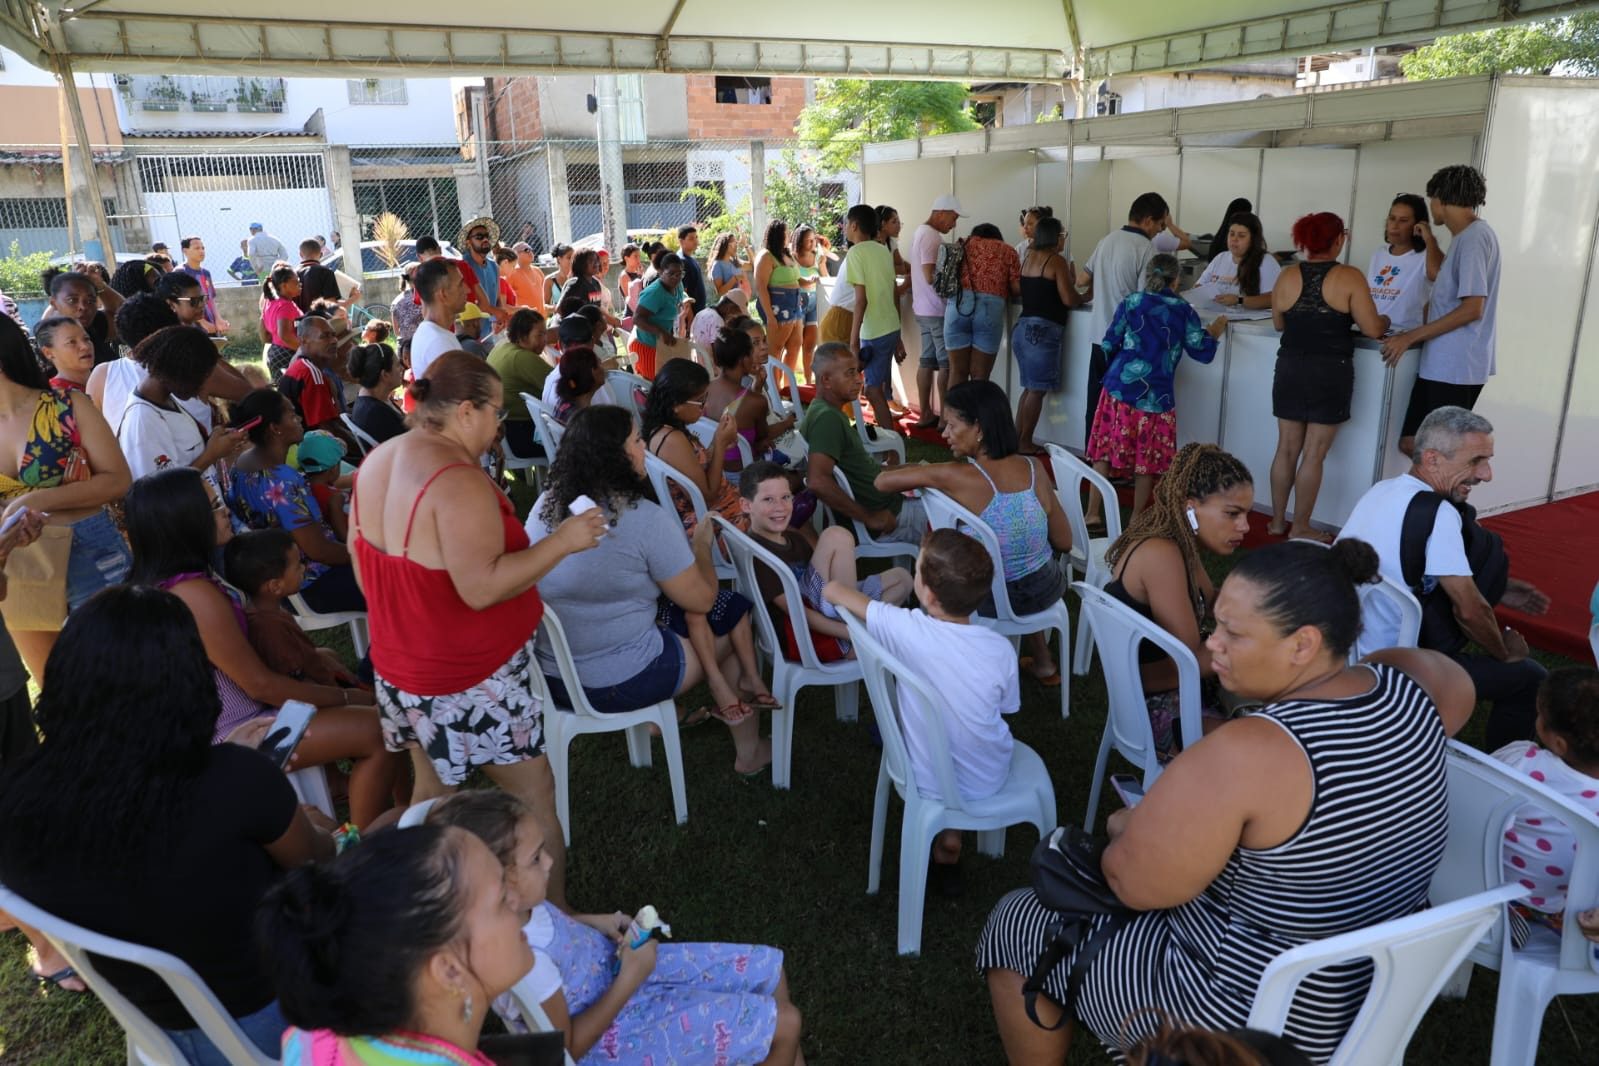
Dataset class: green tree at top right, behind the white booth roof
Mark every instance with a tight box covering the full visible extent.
[1399,13,1599,82]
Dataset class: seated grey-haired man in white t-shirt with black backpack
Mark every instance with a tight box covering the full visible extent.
[1338,408,1549,751]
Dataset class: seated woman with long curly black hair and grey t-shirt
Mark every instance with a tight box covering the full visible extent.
[528,404,776,775]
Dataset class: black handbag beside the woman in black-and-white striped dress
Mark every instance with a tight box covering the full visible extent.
[1022,825,1134,1029]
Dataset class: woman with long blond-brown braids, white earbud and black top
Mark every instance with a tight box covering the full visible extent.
[1105,444,1255,758]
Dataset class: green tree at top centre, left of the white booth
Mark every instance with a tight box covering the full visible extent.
[795,78,979,171]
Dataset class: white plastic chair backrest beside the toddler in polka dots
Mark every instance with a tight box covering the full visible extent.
[1431,740,1599,972]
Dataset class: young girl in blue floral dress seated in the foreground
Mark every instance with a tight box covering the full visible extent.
[427,790,804,1066]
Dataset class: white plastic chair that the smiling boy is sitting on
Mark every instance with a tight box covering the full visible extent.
[713,515,862,788]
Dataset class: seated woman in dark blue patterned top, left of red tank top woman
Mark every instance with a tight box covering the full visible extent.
[227,388,366,614]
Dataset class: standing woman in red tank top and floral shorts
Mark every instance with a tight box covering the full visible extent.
[350,352,604,903]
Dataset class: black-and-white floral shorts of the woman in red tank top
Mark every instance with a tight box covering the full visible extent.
[374,639,544,788]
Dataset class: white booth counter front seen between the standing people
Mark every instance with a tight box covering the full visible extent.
[1036,307,1420,529]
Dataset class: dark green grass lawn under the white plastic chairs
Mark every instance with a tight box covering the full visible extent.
[0,443,1599,1066]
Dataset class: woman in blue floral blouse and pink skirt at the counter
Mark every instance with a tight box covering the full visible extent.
[1084,254,1226,534]
